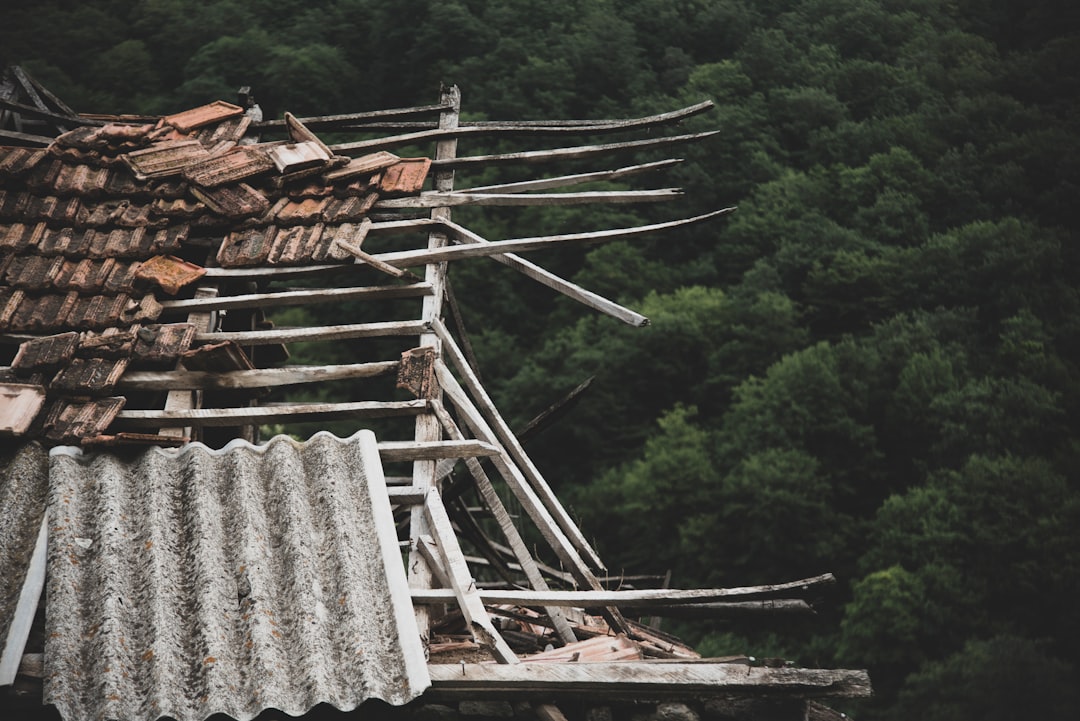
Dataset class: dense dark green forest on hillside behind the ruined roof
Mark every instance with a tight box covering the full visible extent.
[0,0,1080,721]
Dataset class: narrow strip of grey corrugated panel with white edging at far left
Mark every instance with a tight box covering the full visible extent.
[0,443,49,684]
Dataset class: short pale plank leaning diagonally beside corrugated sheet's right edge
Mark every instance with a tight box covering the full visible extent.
[423,488,521,665]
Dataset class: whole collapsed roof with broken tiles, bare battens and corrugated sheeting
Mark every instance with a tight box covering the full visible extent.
[0,67,868,721]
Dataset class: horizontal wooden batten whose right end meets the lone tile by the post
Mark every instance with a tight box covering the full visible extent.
[118,361,400,391]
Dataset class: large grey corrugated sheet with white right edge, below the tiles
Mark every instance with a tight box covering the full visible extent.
[44,431,430,721]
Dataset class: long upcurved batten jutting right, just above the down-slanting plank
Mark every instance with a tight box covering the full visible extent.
[375,207,734,268]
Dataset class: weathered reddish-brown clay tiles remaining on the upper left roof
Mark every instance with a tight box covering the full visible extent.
[0,101,430,444]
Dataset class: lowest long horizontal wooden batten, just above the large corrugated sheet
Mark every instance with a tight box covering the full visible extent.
[117,400,425,425]
